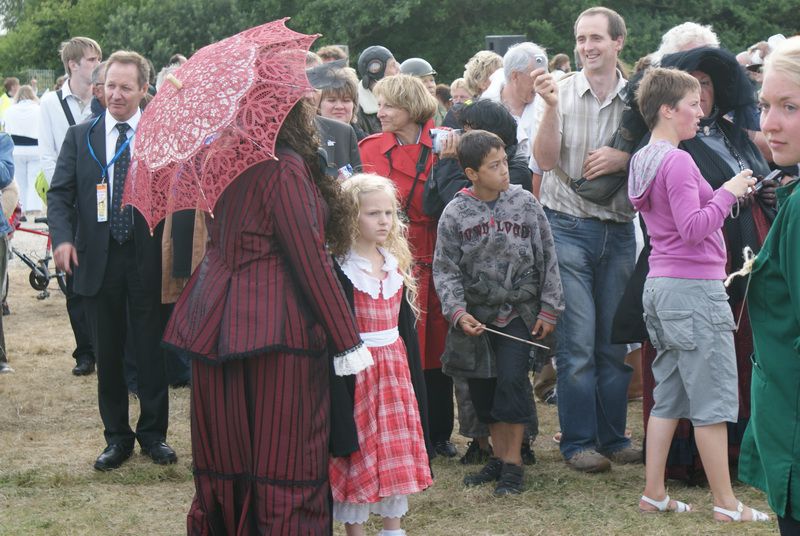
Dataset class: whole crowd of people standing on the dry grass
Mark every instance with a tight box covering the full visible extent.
[0,7,800,536]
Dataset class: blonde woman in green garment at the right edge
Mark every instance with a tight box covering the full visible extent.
[739,37,800,535]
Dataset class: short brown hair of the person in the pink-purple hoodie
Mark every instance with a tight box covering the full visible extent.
[636,67,700,130]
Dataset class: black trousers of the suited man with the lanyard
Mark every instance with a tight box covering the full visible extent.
[85,239,169,447]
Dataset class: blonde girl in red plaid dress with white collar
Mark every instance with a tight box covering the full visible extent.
[329,174,432,536]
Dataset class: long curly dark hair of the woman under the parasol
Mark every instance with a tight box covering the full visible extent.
[278,99,351,250]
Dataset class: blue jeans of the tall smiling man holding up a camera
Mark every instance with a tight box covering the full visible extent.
[545,209,636,458]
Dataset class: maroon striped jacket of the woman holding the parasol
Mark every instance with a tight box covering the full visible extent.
[164,148,361,361]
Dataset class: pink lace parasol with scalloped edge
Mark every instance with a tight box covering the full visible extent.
[123,19,318,229]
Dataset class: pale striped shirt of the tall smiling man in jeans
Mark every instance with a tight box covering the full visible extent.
[534,71,634,222]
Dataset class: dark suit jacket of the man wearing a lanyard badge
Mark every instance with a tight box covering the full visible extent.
[47,116,162,296]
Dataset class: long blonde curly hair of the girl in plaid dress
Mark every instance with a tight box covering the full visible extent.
[329,173,420,317]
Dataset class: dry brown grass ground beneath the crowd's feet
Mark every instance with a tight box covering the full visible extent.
[0,263,777,536]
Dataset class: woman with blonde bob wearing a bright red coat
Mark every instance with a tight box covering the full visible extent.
[359,74,457,457]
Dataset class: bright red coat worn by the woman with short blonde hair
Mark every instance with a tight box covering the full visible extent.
[358,120,449,369]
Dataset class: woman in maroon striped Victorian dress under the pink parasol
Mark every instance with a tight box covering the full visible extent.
[165,101,371,535]
